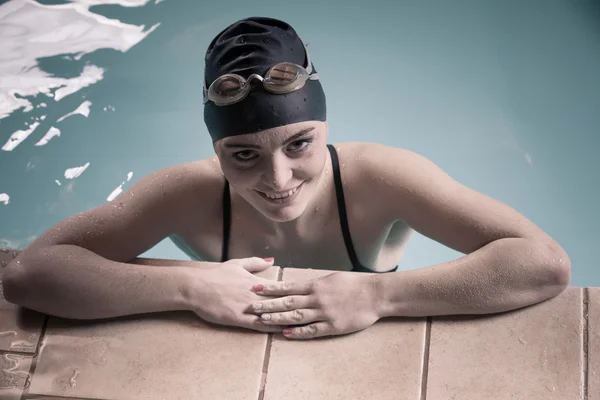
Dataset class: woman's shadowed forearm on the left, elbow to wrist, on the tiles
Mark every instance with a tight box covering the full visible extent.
[3,245,206,319]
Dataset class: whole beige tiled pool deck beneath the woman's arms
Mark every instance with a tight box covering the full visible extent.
[0,250,600,400]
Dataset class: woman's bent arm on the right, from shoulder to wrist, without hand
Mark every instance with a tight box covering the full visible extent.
[368,145,570,317]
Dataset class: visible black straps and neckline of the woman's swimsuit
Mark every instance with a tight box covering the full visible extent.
[221,144,398,272]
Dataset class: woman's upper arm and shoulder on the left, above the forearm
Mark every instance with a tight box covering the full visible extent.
[30,159,223,261]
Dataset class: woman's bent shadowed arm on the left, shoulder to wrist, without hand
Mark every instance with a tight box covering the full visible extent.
[3,162,218,319]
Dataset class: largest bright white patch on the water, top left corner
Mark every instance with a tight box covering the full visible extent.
[0,0,159,120]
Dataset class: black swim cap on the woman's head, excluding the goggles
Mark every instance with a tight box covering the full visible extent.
[204,17,326,143]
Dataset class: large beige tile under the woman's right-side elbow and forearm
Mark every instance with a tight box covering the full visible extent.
[427,287,583,400]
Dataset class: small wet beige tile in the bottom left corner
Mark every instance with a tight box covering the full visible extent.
[0,353,32,400]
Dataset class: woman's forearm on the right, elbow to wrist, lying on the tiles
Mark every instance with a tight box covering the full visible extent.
[372,238,570,317]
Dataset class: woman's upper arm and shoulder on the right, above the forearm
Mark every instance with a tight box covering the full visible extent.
[336,143,550,253]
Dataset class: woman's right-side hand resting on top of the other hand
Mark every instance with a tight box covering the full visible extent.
[252,272,380,339]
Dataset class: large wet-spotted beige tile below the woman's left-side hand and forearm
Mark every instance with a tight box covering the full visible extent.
[30,268,278,400]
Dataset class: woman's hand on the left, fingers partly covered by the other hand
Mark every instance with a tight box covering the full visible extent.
[186,257,283,332]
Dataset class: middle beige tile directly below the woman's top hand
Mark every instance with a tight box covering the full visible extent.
[264,269,426,400]
